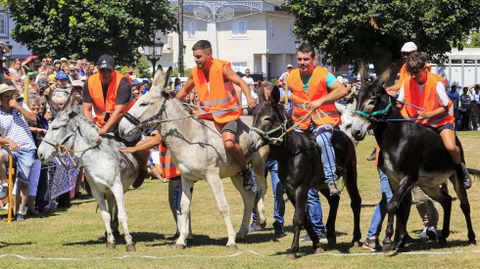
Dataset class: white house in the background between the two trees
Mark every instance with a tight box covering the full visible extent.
[160,0,297,78]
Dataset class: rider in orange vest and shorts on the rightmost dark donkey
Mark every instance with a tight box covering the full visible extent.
[397,52,472,189]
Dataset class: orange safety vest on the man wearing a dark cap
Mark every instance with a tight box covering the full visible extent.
[88,71,135,127]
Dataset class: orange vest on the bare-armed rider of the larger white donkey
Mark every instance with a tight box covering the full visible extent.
[192,60,242,123]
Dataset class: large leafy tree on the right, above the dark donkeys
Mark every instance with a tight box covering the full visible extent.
[286,0,480,72]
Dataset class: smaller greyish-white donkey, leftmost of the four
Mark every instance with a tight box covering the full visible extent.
[38,97,141,251]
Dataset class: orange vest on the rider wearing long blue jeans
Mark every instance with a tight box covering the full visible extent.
[288,66,340,130]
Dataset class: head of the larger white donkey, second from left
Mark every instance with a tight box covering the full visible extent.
[118,67,173,140]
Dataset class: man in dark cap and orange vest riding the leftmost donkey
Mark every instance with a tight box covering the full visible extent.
[82,54,148,188]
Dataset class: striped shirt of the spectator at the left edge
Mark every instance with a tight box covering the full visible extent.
[0,108,36,151]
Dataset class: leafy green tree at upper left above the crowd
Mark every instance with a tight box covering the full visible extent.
[1,0,176,64]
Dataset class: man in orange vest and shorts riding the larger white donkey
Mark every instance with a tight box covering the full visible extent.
[176,40,256,190]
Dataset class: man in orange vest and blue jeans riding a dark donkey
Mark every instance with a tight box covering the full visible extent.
[288,43,348,196]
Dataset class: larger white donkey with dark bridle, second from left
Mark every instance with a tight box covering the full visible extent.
[118,68,268,249]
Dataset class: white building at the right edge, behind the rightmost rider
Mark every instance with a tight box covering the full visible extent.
[431,48,480,87]
